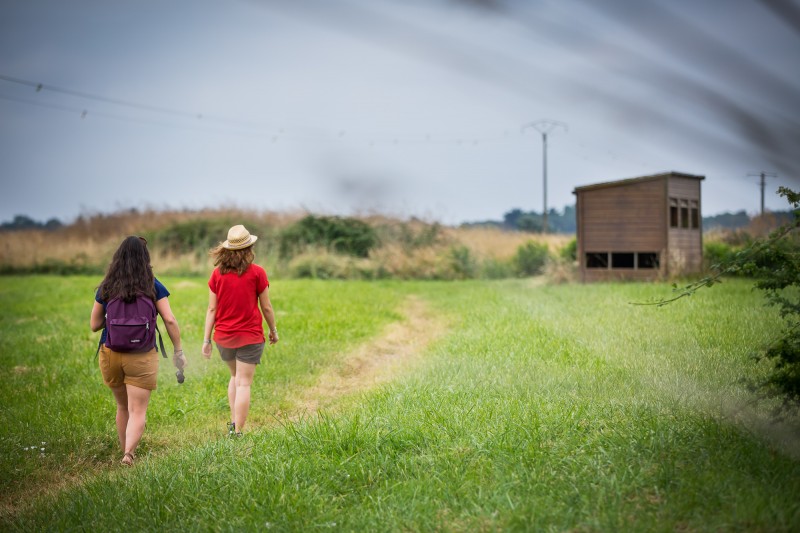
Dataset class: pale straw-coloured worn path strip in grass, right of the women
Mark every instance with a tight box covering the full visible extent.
[282,295,449,416]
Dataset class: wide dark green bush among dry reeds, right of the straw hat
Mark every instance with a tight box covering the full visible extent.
[278,215,378,258]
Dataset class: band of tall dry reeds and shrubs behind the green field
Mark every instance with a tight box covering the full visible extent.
[0,208,573,279]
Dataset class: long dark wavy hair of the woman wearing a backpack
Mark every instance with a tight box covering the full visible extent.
[97,237,156,302]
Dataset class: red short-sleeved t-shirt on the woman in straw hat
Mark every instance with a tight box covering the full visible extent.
[208,264,269,348]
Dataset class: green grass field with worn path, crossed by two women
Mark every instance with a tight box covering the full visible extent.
[0,276,800,531]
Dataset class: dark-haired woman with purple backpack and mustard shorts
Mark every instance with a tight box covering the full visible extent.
[90,237,187,466]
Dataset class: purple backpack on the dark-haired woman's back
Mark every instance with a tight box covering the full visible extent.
[106,294,167,357]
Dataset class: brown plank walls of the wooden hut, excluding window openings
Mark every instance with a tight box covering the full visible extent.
[574,172,705,282]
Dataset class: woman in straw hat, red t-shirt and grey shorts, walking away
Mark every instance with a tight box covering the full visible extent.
[203,225,278,437]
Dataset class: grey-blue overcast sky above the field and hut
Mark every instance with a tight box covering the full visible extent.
[0,0,800,224]
